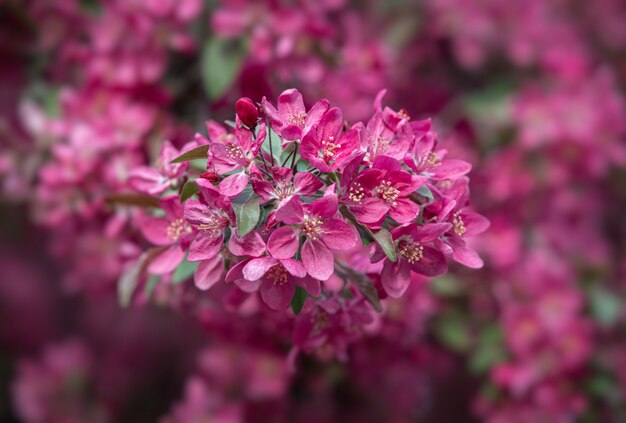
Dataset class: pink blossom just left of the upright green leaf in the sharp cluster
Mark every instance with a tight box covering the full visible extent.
[185,179,235,261]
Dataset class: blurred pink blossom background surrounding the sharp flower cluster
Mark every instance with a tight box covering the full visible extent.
[0,0,626,423]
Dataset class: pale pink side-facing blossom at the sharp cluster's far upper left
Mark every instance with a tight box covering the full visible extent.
[128,141,189,195]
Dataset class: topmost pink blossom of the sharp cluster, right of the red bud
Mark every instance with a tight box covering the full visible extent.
[262,88,330,141]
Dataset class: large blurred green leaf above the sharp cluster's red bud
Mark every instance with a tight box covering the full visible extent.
[200,37,247,100]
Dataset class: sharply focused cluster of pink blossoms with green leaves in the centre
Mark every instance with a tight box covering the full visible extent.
[118,89,489,320]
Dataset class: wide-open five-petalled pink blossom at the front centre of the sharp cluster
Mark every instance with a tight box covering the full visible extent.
[267,187,357,281]
